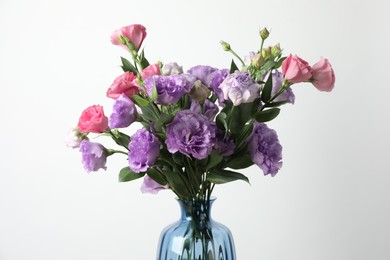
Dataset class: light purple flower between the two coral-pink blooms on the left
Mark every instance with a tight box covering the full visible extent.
[109,94,137,128]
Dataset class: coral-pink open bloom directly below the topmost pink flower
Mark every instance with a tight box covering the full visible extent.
[106,71,139,99]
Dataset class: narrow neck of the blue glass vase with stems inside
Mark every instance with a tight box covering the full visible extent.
[178,198,215,222]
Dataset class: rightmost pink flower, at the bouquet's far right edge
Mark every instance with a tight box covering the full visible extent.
[311,57,335,92]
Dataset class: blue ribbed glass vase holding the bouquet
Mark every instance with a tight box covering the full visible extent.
[157,198,236,260]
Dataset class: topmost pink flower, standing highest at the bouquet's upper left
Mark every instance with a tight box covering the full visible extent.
[111,24,146,50]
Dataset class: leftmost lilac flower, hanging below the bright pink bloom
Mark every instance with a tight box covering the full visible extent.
[80,140,108,172]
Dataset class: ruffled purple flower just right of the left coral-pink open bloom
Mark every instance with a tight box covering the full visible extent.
[145,74,193,105]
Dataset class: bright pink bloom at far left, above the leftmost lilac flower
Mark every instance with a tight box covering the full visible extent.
[78,105,108,133]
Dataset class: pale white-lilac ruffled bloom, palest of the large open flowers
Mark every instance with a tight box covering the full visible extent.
[219,71,260,106]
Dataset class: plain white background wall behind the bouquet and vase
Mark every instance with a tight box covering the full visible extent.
[0,0,390,260]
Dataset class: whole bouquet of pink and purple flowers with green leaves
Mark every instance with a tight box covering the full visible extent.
[67,24,335,259]
